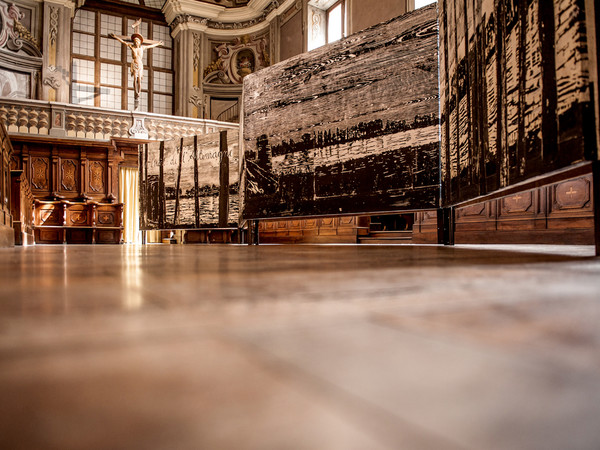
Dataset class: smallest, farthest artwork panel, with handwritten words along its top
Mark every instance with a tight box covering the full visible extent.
[140,130,239,230]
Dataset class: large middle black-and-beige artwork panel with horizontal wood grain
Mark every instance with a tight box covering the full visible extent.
[243,5,440,218]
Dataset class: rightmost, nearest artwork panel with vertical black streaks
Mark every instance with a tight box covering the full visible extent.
[439,0,596,204]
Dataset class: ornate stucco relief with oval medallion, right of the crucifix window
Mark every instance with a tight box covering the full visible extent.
[204,35,269,84]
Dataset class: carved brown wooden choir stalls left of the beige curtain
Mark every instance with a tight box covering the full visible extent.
[11,136,127,244]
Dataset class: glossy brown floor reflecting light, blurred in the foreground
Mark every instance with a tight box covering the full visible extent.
[0,245,600,450]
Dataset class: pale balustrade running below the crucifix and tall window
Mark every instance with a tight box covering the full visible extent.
[0,98,239,140]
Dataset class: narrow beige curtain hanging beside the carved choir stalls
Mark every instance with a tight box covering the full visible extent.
[119,167,140,244]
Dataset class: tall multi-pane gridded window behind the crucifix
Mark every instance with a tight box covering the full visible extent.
[71,9,173,114]
